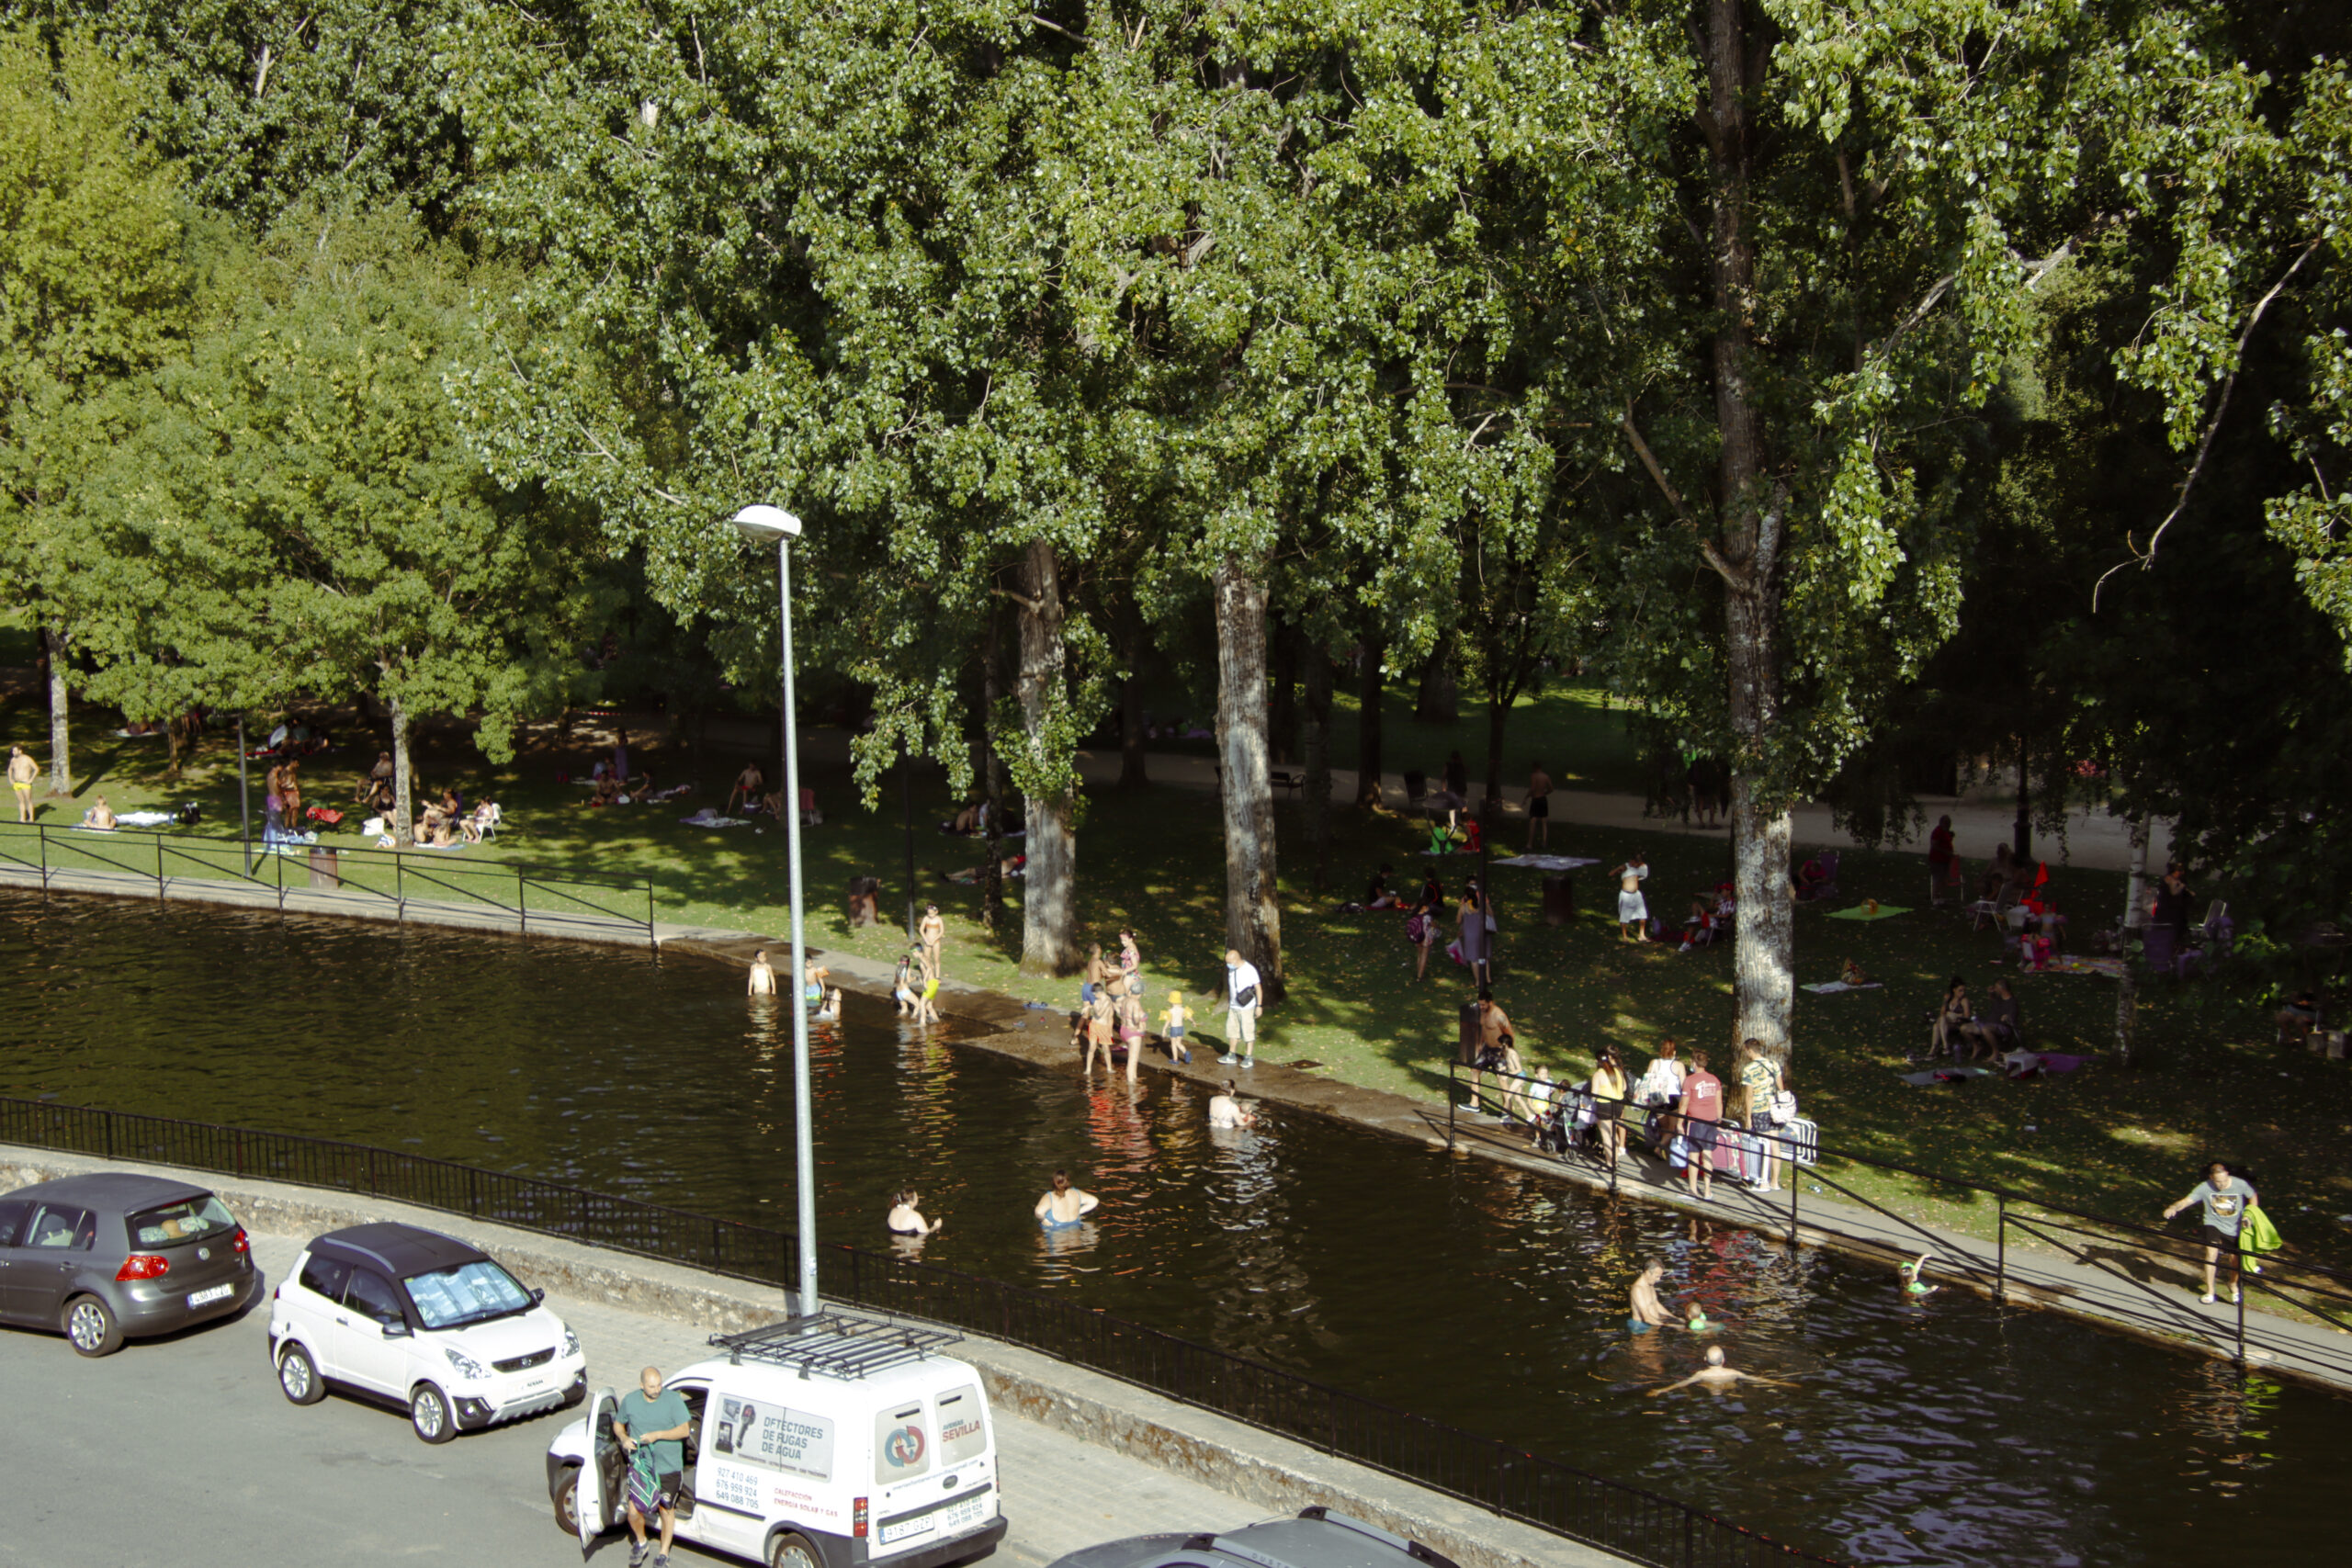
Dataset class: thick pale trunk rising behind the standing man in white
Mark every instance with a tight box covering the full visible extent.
[1216,555,1282,997]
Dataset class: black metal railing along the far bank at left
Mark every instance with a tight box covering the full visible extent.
[0,823,654,942]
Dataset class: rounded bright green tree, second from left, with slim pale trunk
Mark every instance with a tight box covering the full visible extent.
[89,207,595,840]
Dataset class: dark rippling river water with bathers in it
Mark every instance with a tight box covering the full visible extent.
[0,894,2352,1568]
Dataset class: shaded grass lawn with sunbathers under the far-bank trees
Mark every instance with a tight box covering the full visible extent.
[18,694,2352,1262]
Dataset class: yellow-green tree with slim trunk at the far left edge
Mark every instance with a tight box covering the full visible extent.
[0,28,190,795]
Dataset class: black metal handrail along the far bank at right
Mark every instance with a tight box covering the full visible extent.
[1446,1063,2352,1378]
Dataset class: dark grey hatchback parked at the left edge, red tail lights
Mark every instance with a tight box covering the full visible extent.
[0,1170,261,1357]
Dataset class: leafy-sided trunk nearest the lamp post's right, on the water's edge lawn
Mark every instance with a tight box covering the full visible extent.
[1013,538,1077,976]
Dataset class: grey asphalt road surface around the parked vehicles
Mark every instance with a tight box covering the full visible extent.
[0,1236,1265,1568]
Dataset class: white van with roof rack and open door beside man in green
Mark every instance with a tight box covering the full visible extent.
[548,1309,1004,1568]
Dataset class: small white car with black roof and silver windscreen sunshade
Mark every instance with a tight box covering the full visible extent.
[270,1224,588,1443]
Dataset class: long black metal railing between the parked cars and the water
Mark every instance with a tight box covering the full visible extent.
[0,1098,1832,1568]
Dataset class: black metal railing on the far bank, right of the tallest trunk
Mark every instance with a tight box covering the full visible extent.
[1446,1063,2352,1378]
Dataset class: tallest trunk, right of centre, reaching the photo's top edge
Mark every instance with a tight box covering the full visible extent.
[1708,0,1797,1060]
